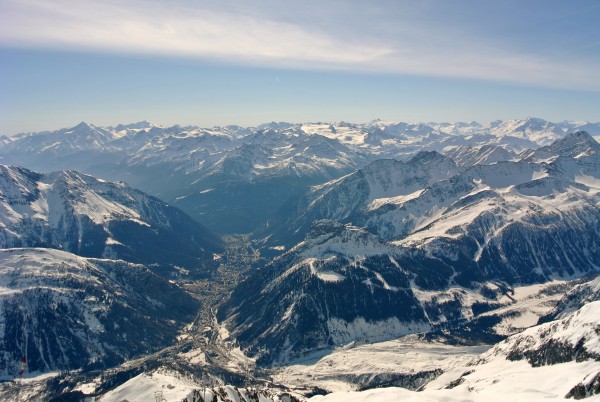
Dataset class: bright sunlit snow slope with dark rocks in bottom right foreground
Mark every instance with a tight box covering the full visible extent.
[310,301,600,402]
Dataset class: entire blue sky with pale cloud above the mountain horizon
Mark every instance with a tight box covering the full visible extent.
[0,0,600,135]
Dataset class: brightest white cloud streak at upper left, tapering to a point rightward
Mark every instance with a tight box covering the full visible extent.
[0,0,391,65]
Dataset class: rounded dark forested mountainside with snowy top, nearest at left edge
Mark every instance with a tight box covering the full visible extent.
[0,248,198,374]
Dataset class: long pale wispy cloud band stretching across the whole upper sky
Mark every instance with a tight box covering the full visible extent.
[0,0,600,90]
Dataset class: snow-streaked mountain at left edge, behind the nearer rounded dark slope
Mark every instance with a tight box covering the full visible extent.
[0,165,221,271]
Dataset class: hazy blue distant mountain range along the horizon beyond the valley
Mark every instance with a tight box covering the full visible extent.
[0,118,600,233]
